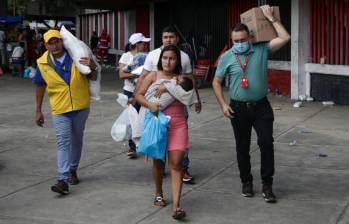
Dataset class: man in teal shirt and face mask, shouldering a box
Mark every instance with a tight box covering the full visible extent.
[213,5,290,203]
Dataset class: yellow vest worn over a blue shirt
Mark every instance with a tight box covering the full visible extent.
[37,51,90,115]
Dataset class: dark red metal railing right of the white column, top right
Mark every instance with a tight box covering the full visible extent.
[310,0,349,65]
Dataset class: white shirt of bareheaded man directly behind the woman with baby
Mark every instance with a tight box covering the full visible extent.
[143,48,192,74]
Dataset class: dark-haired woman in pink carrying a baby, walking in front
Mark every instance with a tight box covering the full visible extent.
[136,45,189,219]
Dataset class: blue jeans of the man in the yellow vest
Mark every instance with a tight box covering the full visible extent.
[52,109,90,181]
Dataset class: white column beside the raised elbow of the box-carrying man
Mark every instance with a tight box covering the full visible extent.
[291,0,310,99]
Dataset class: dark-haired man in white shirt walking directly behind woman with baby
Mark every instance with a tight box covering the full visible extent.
[136,26,201,183]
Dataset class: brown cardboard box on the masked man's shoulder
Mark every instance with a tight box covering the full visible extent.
[240,6,280,43]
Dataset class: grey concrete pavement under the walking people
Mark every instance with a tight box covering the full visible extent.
[0,72,349,224]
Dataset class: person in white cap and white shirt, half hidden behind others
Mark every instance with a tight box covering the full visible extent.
[119,33,150,159]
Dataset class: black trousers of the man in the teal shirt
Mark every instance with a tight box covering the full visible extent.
[230,97,274,184]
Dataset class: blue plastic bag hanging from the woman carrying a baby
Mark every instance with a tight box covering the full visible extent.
[137,111,170,161]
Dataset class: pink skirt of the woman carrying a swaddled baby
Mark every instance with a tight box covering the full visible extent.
[163,100,189,151]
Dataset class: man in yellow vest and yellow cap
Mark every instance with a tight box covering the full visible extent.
[33,29,97,195]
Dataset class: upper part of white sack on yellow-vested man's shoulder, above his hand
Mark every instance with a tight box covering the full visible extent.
[60,26,92,75]
